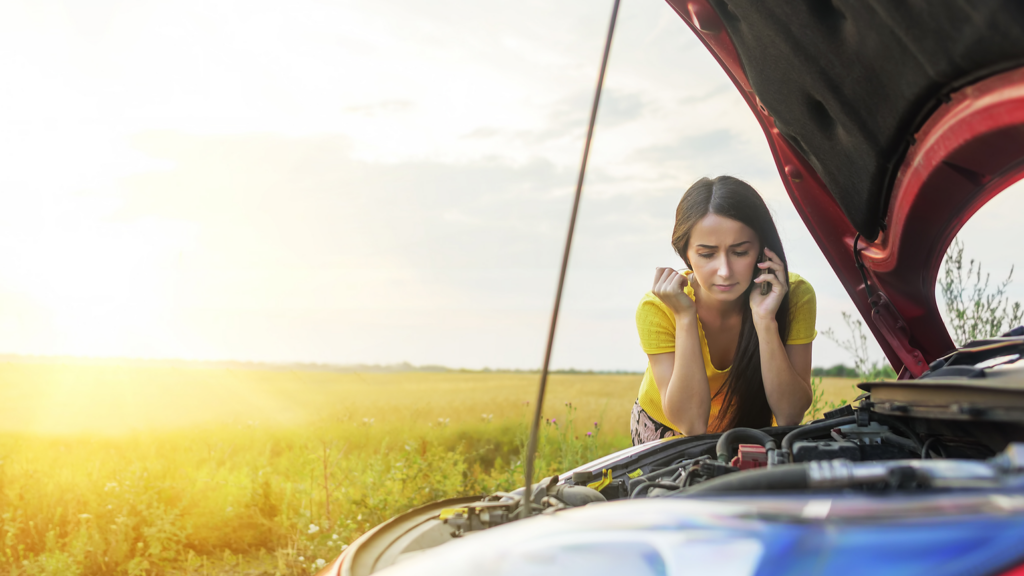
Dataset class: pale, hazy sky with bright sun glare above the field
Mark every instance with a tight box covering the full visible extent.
[0,0,1024,370]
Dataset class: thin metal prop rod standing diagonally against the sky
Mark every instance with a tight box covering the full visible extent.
[519,0,620,518]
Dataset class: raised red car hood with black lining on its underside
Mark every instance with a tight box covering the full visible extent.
[668,0,1024,378]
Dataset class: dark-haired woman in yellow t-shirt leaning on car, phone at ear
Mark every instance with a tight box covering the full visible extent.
[630,176,817,445]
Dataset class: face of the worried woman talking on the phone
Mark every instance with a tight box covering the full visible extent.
[686,214,762,300]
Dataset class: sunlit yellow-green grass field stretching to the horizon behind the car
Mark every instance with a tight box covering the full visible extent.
[0,362,855,576]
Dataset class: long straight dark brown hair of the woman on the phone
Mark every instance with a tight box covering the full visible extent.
[672,176,790,431]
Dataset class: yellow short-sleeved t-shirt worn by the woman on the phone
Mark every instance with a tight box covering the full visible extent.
[637,272,818,433]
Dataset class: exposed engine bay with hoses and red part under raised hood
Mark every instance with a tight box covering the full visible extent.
[441,336,1024,537]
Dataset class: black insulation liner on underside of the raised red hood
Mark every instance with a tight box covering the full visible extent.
[710,0,1024,241]
